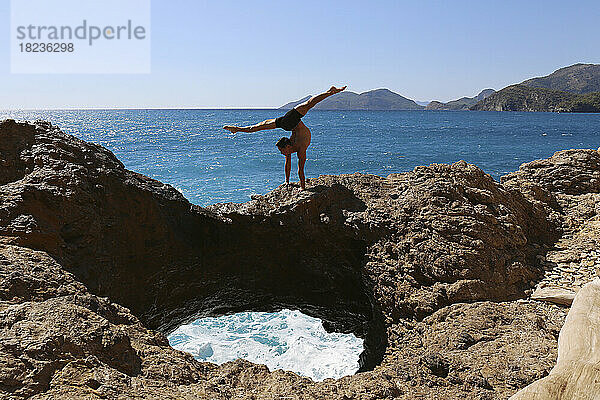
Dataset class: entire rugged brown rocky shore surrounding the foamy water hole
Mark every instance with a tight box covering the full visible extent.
[0,120,600,399]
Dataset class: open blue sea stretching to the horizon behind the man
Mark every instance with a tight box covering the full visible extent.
[0,110,600,205]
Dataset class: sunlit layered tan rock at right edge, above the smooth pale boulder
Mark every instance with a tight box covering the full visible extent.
[502,150,600,296]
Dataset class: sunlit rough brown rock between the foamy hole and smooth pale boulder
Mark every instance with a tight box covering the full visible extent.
[382,302,566,399]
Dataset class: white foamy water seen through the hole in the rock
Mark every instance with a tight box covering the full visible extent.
[168,309,364,381]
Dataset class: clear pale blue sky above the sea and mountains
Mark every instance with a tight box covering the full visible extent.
[0,0,600,109]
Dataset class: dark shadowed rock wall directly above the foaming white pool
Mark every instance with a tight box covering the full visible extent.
[155,185,385,369]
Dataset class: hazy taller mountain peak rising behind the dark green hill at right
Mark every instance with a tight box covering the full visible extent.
[521,64,600,94]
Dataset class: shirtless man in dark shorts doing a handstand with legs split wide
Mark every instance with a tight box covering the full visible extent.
[223,86,346,190]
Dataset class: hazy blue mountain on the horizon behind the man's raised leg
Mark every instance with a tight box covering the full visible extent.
[280,89,425,110]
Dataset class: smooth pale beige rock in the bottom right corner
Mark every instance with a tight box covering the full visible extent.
[511,279,600,400]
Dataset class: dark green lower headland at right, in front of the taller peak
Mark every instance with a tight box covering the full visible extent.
[471,84,600,112]
